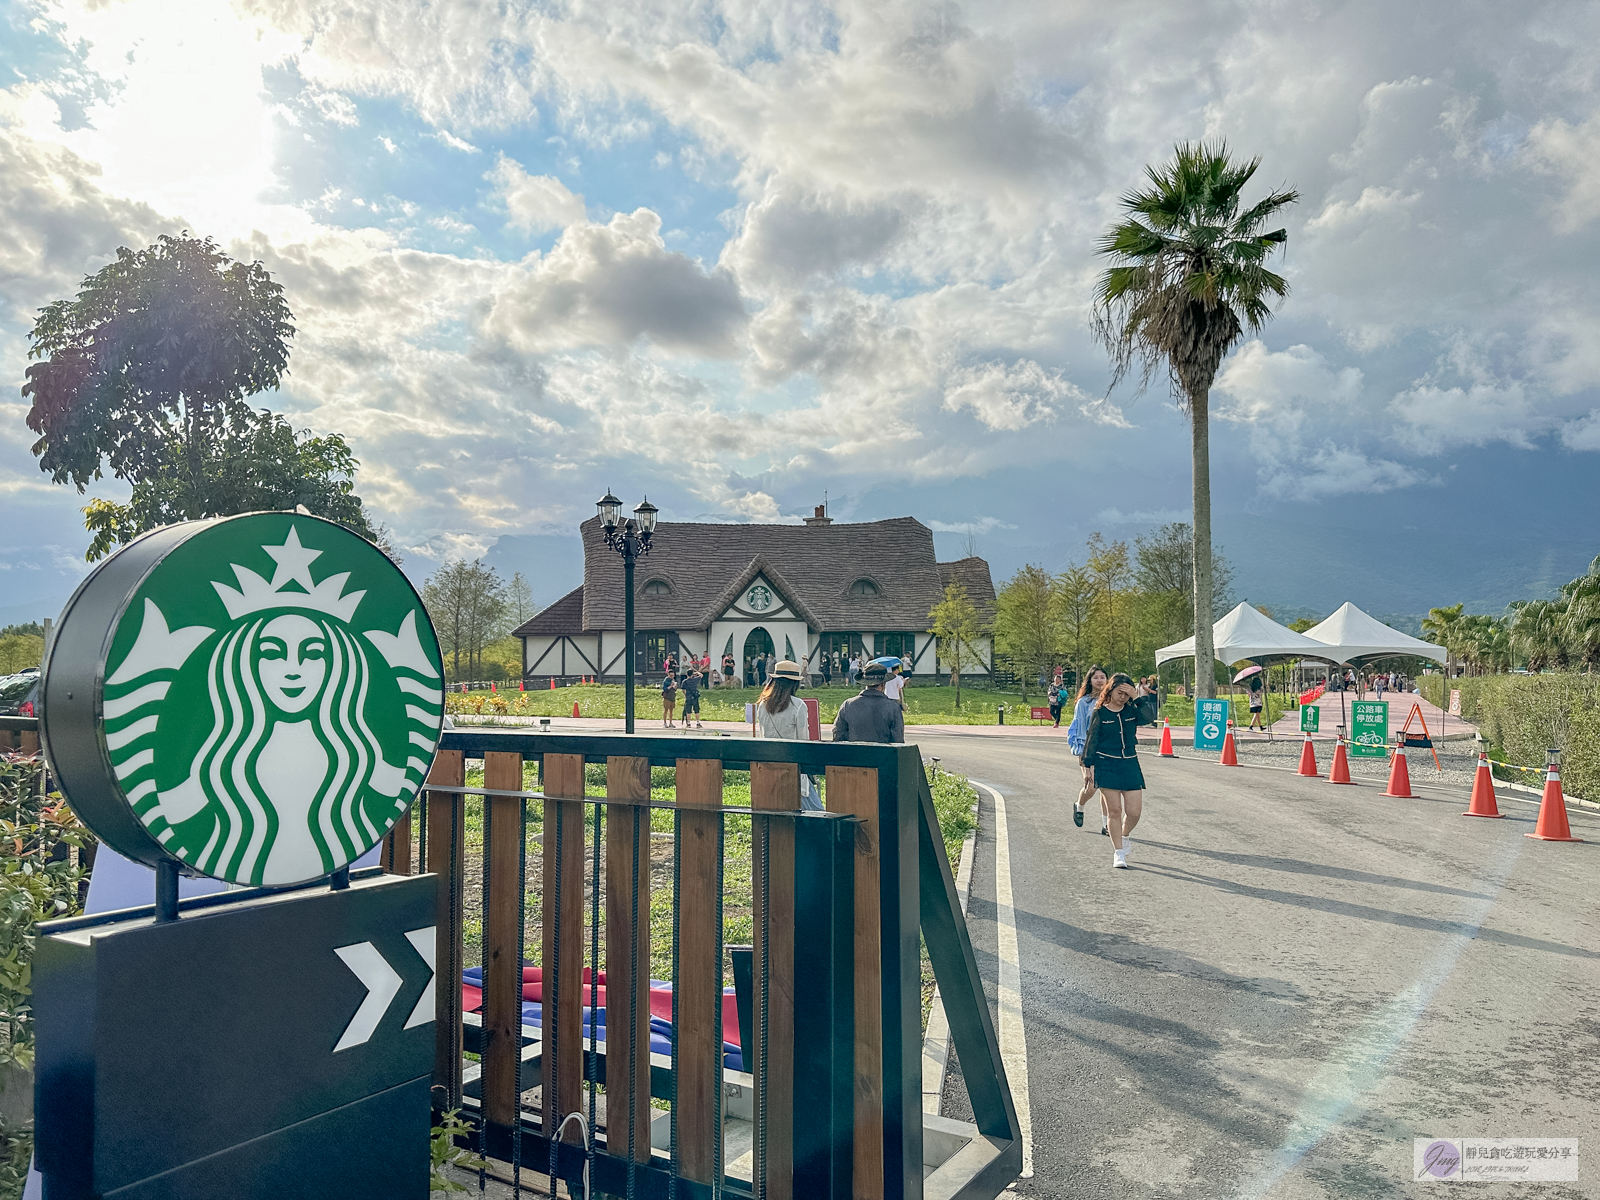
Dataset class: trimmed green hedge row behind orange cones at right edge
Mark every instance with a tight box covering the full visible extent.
[1419,670,1600,800]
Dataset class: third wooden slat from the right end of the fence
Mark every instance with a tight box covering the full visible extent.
[672,758,722,1184]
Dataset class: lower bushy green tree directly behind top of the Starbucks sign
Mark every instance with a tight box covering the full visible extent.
[83,410,374,562]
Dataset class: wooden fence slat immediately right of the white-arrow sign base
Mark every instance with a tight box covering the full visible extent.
[427,750,467,1110]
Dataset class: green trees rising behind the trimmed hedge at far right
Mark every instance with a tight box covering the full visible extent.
[1422,558,1600,675]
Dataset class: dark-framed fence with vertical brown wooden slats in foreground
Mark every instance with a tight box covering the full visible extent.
[398,730,1021,1200]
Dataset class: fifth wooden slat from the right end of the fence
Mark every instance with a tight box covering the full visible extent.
[541,754,584,1142]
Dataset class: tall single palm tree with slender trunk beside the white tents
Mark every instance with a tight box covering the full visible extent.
[1094,142,1299,698]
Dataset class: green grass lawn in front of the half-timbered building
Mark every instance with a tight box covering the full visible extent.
[445,683,1045,725]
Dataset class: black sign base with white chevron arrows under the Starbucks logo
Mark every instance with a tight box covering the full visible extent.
[34,875,435,1200]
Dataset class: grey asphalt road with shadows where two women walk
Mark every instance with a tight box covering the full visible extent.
[910,730,1600,1200]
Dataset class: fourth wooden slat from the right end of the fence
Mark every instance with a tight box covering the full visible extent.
[605,757,650,1163]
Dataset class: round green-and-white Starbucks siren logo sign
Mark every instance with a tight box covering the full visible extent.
[40,512,445,886]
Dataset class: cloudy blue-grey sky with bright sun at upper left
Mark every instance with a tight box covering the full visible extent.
[0,0,1600,611]
